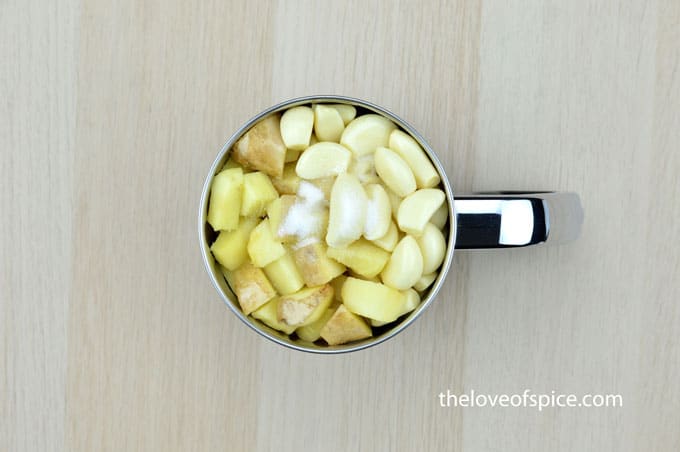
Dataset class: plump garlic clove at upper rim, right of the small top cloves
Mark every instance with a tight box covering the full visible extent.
[340,114,397,156]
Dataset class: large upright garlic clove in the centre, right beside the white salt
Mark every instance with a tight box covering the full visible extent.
[326,173,367,248]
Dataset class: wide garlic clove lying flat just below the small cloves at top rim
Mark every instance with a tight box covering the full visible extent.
[295,141,352,179]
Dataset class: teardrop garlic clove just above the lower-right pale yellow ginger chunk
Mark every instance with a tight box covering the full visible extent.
[380,235,423,290]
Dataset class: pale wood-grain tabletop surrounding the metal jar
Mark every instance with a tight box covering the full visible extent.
[0,0,680,452]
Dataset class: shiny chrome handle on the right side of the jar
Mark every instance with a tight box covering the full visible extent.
[454,192,583,249]
